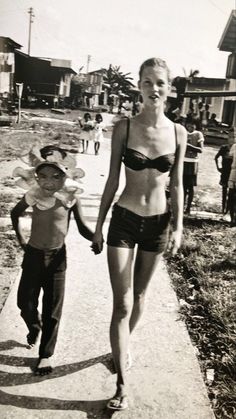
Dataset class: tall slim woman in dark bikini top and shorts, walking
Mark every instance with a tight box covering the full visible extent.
[93,58,187,410]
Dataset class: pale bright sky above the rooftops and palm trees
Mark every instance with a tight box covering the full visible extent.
[0,0,236,83]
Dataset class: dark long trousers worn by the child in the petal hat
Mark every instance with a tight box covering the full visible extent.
[17,245,66,358]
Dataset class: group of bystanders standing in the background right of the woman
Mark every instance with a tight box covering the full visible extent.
[167,101,236,227]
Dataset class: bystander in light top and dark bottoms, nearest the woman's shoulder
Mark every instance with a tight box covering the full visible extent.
[183,122,204,214]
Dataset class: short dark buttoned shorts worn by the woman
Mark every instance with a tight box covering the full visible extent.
[107,204,170,253]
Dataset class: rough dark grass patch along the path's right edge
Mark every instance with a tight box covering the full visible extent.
[168,218,236,419]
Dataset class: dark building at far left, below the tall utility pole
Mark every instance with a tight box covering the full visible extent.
[0,36,76,104]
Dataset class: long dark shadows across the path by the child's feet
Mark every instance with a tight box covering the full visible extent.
[0,340,114,419]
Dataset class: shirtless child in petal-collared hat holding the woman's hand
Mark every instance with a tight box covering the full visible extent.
[11,146,93,375]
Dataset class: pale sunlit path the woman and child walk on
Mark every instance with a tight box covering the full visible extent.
[0,135,214,419]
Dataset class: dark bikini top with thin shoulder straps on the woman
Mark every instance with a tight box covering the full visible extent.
[122,118,177,173]
